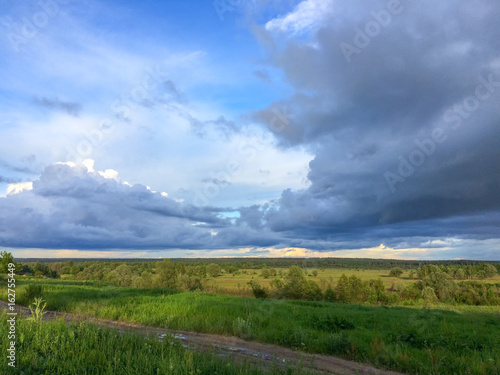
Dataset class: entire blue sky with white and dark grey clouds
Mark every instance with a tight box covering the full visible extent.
[0,0,500,260]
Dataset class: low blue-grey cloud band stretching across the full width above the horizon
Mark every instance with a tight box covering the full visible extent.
[0,160,500,259]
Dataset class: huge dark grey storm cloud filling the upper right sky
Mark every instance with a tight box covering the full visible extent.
[251,1,500,247]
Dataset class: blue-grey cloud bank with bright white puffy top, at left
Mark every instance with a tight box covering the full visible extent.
[0,164,277,249]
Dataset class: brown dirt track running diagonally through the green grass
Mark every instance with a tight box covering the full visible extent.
[0,301,402,375]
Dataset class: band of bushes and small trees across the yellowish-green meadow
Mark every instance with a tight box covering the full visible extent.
[0,253,500,305]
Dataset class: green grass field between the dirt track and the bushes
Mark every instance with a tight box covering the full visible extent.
[0,281,500,375]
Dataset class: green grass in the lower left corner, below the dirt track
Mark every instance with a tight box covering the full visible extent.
[0,313,301,375]
